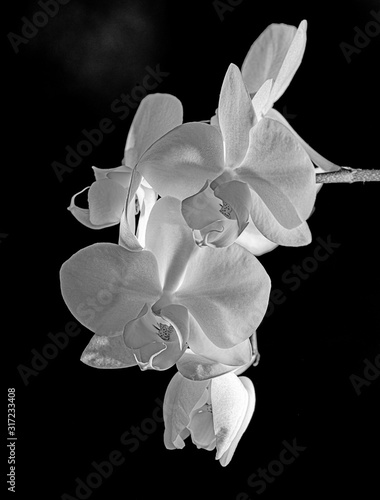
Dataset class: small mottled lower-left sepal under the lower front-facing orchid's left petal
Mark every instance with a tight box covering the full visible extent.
[80,335,137,368]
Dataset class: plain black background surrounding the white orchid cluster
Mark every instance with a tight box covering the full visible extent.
[0,0,380,500]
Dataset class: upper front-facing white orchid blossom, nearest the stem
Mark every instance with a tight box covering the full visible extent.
[137,64,316,255]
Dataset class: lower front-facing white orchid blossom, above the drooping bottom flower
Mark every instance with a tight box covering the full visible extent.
[61,197,270,371]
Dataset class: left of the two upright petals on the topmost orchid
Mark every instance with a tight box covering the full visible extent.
[241,24,297,94]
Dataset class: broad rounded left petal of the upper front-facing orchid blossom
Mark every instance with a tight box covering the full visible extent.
[137,123,224,200]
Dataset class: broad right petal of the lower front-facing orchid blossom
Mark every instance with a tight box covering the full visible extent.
[175,245,270,349]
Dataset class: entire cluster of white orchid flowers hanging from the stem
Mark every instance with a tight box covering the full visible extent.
[60,21,340,466]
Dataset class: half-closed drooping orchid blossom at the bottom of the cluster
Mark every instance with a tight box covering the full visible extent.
[163,372,256,467]
